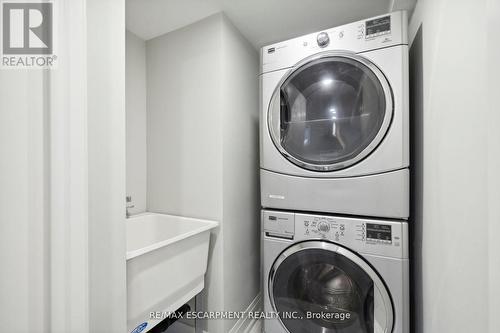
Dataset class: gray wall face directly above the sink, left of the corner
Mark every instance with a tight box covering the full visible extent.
[146,15,222,220]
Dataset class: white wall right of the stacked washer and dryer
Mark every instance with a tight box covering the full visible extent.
[410,0,500,333]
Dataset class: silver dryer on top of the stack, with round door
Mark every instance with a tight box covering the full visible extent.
[260,12,409,219]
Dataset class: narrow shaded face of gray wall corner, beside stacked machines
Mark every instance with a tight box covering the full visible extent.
[222,16,260,331]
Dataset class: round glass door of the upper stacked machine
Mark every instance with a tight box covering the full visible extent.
[268,52,393,171]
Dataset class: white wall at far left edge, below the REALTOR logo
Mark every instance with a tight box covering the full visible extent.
[0,69,50,333]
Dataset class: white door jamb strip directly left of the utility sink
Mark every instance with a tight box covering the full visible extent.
[85,0,127,333]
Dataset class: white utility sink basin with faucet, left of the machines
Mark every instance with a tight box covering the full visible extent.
[126,213,218,333]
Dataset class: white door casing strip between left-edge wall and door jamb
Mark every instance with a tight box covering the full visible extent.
[47,0,89,333]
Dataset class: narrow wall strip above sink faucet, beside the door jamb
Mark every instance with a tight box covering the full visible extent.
[125,31,147,214]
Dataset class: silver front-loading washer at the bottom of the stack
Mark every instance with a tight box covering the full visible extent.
[262,210,409,333]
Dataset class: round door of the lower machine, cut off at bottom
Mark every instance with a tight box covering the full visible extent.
[269,241,393,333]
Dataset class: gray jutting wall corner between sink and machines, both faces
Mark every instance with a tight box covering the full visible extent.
[146,14,260,333]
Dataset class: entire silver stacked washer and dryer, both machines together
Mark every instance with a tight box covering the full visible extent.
[260,12,409,333]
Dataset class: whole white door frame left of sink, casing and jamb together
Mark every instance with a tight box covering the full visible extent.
[45,0,126,333]
